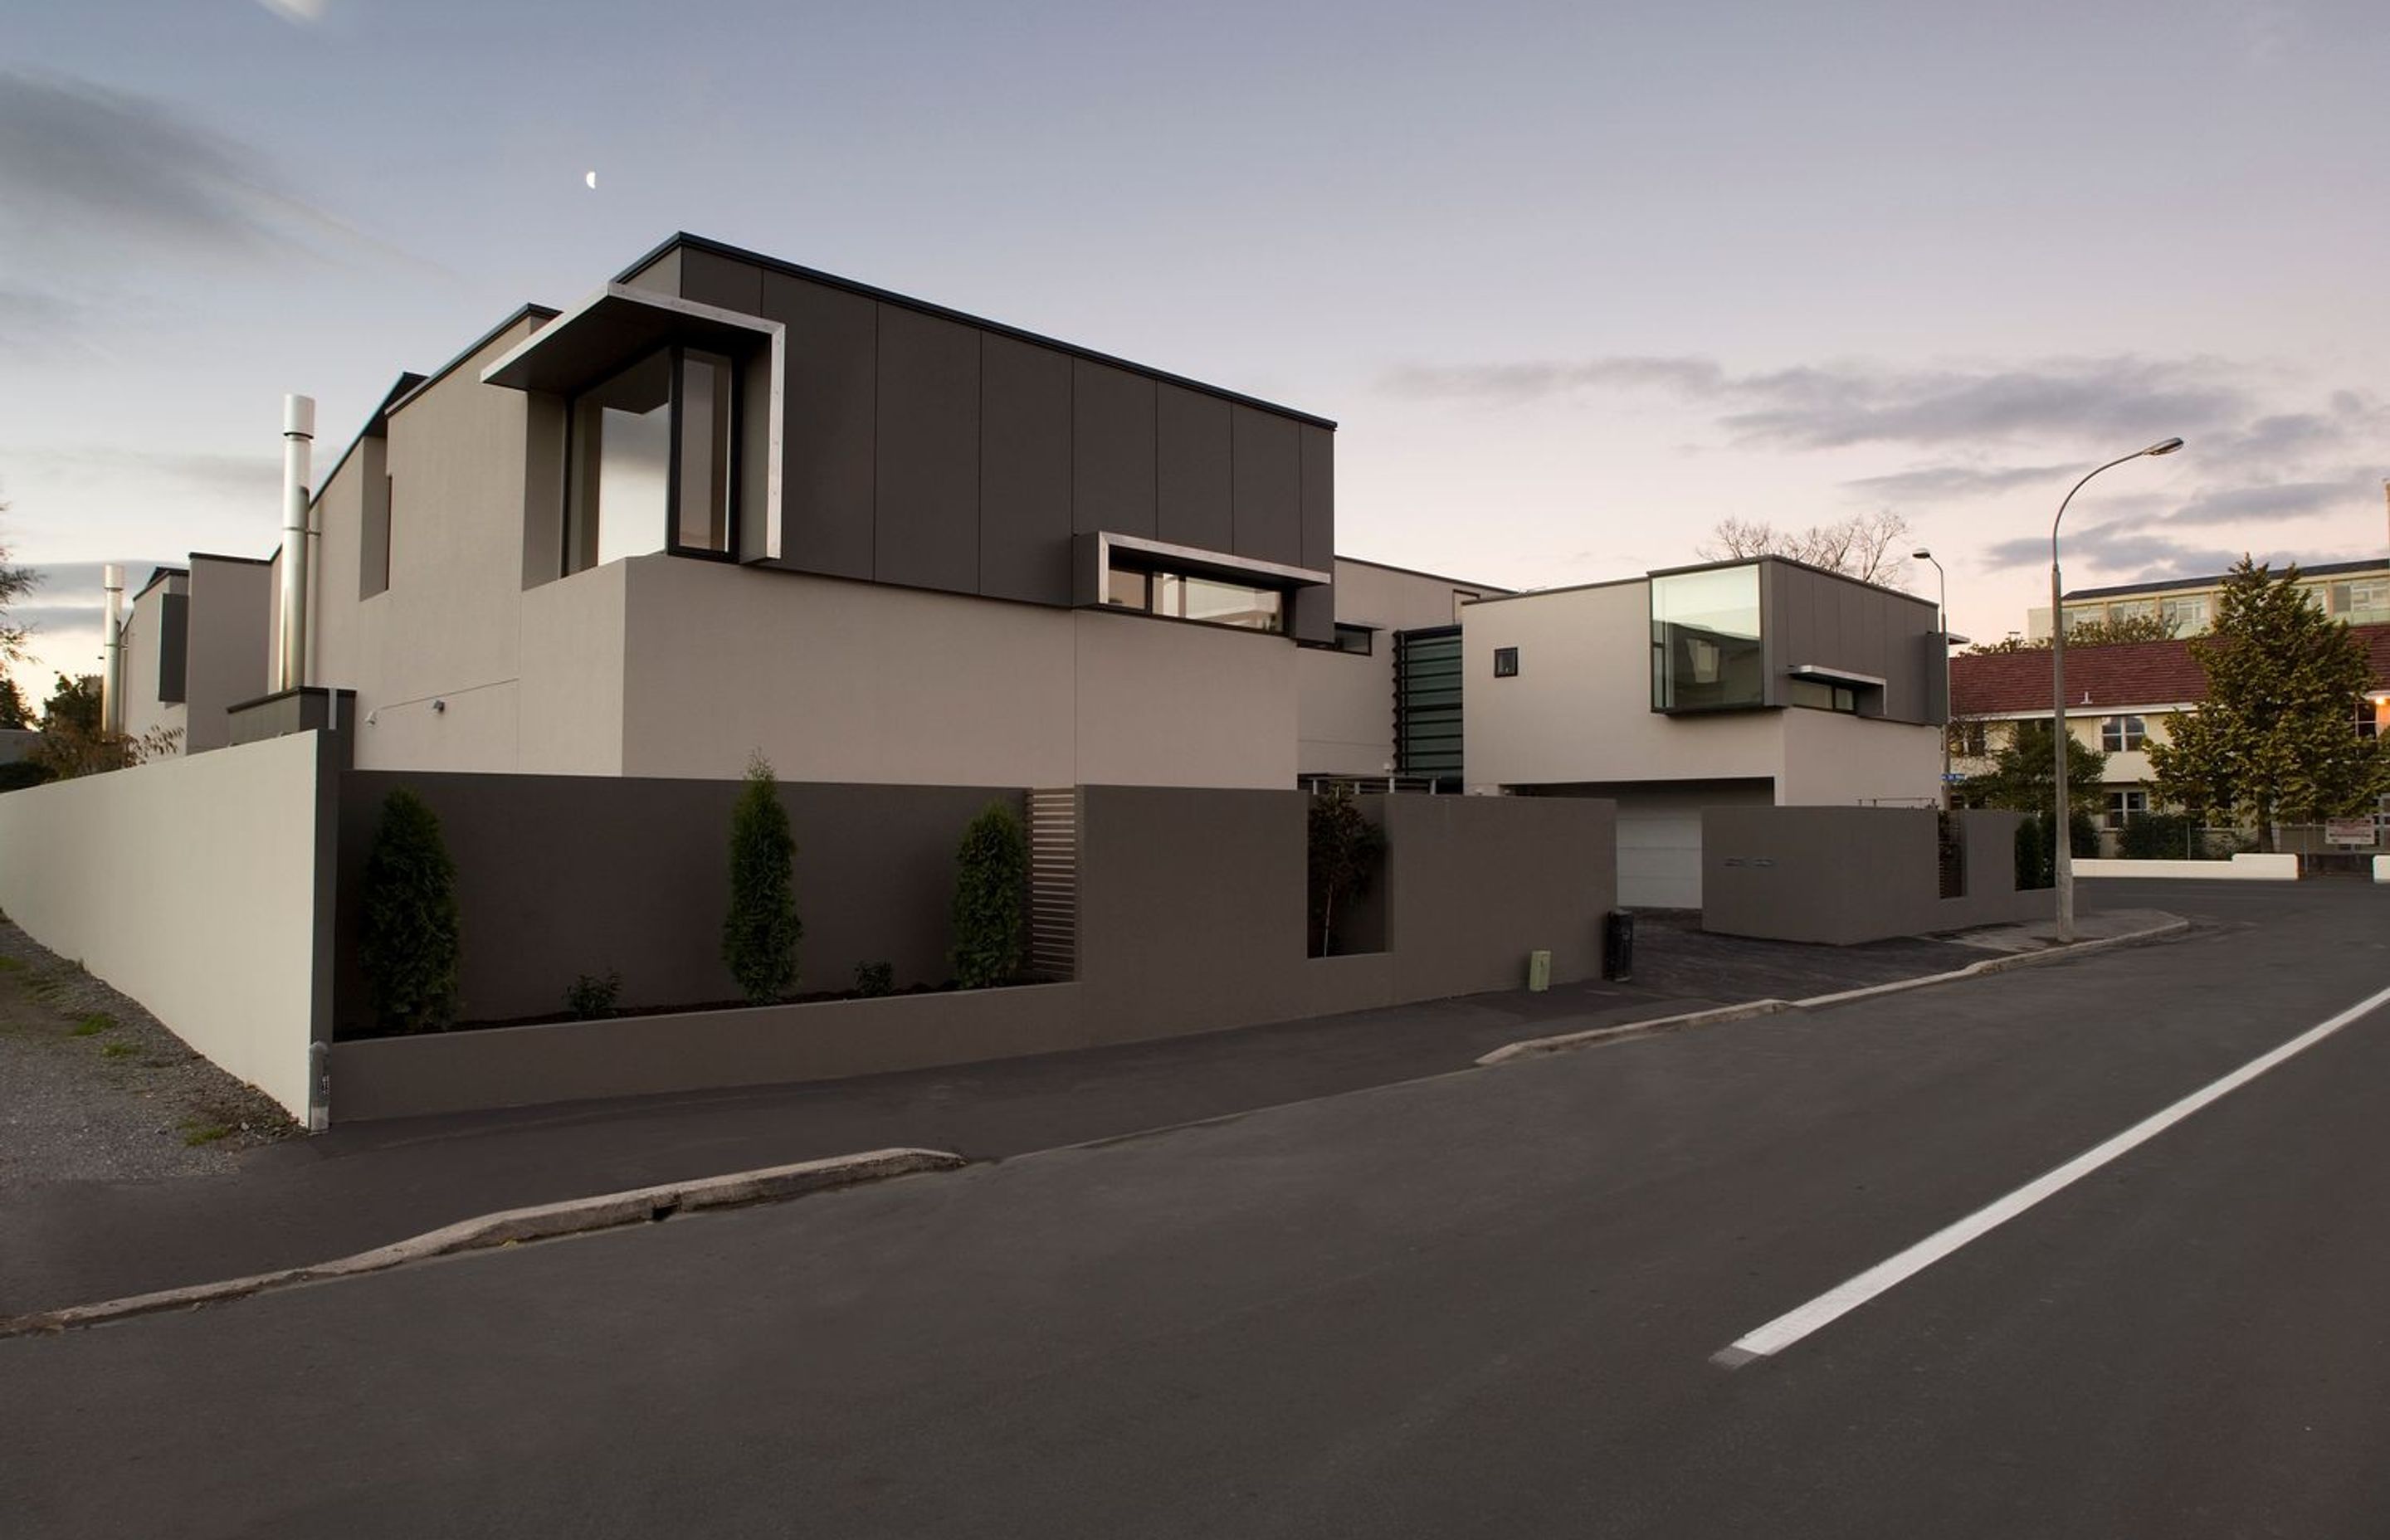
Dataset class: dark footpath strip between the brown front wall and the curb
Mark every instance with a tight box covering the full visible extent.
[0,909,2173,1315]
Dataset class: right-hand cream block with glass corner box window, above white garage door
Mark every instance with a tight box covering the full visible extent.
[1458,558,1948,909]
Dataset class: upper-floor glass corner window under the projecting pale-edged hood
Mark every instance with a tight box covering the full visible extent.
[564,347,739,572]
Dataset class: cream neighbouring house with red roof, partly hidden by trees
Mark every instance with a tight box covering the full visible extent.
[1950,624,2390,849]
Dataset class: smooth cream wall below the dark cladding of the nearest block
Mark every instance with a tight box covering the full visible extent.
[622,555,1298,787]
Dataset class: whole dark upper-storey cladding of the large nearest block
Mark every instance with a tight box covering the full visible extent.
[655,246,1336,641]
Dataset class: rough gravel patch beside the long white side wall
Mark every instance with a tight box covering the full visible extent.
[0,921,296,1188]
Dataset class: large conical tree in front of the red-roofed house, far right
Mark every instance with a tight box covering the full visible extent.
[2149,555,2390,851]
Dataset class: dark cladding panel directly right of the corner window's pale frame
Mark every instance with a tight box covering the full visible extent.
[763,273,880,578]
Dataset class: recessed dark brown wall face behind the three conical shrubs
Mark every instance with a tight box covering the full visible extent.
[334,770,1021,1028]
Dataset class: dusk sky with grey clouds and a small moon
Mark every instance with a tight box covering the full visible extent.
[0,0,2390,699]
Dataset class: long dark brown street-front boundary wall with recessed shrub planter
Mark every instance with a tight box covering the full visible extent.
[332,775,1613,1119]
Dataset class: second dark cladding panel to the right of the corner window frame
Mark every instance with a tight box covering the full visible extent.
[872,304,980,593]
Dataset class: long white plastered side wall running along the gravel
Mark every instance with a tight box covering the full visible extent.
[0,732,332,1119]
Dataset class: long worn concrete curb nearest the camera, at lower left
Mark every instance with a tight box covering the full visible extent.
[0,1150,970,1337]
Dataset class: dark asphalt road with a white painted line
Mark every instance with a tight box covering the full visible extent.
[0,882,2390,1535]
